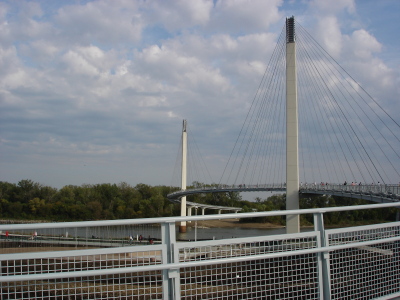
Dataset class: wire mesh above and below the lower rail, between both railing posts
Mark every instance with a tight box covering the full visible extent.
[179,233,320,299]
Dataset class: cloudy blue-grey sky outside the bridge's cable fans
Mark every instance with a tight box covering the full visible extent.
[0,0,400,188]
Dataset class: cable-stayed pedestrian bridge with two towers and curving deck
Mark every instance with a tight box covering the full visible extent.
[168,18,400,232]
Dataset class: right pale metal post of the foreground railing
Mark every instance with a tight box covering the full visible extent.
[314,212,331,300]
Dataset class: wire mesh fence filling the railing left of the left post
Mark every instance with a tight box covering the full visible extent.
[1,245,162,299]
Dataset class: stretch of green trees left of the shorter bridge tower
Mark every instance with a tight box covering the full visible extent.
[0,180,175,221]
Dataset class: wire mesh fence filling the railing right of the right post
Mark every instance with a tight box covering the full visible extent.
[328,224,400,299]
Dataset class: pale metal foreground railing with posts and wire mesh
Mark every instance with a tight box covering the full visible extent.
[0,203,400,299]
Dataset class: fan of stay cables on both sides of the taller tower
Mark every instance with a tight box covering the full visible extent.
[219,18,400,185]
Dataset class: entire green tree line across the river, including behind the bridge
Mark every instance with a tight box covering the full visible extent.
[0,179,396,225]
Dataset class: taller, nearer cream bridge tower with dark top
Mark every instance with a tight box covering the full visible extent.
[286,17,300,233]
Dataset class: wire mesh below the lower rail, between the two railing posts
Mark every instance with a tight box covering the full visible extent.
[181,254,320,299]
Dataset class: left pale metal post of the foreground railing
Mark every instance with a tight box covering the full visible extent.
[161,222,181,300]
